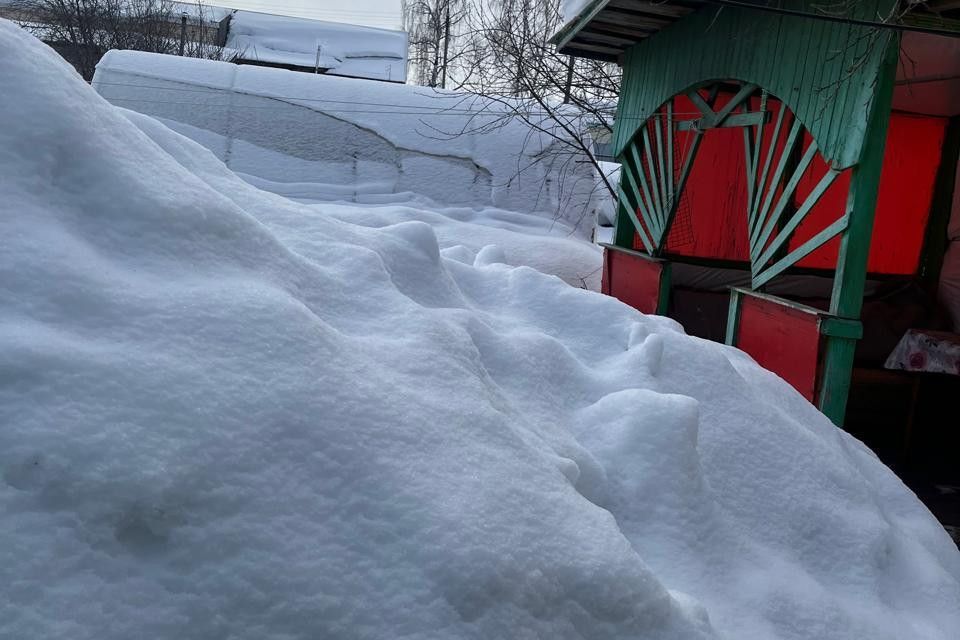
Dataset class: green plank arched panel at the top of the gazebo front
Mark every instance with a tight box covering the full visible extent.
[614,0,897,170]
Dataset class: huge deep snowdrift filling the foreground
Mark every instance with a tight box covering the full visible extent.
[0,22,960,640]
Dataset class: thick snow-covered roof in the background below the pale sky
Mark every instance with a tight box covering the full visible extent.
[226,11,407,82]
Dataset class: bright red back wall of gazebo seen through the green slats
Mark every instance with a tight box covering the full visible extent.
[634,96,947,274]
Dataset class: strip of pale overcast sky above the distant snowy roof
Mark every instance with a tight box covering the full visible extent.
[225,0,400,29]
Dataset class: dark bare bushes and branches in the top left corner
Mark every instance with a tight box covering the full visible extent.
[11,0,222,80]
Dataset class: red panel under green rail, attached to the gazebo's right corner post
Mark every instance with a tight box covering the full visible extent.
[737,295,820,402]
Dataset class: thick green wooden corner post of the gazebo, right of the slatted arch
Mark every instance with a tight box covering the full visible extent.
[818,33,900,426]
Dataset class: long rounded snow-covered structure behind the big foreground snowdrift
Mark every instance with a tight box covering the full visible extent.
[94,51,603,237]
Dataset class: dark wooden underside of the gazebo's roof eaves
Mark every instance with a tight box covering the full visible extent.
[550,0,960,62]
